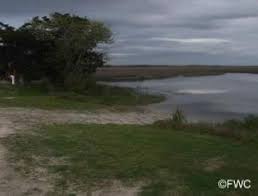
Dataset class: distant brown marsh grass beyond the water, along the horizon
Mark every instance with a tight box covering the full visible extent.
[96,65,258,81]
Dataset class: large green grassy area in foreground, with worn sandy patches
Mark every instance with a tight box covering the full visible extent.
[2,117,258,196]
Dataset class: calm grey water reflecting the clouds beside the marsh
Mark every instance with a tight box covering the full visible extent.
[104,74,258,121]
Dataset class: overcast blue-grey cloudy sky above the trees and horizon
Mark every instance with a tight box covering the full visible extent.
[0,0,258,65]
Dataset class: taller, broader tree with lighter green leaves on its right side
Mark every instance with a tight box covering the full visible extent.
[20,13,112,87]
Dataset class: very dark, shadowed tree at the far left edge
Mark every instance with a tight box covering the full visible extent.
[0,23,45,81]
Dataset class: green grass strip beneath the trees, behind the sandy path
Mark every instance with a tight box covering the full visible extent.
[0,84,164,111]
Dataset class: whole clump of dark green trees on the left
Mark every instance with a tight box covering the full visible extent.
[0,13,112,88]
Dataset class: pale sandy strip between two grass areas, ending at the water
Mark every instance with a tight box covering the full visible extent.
[0,108,168,125]
